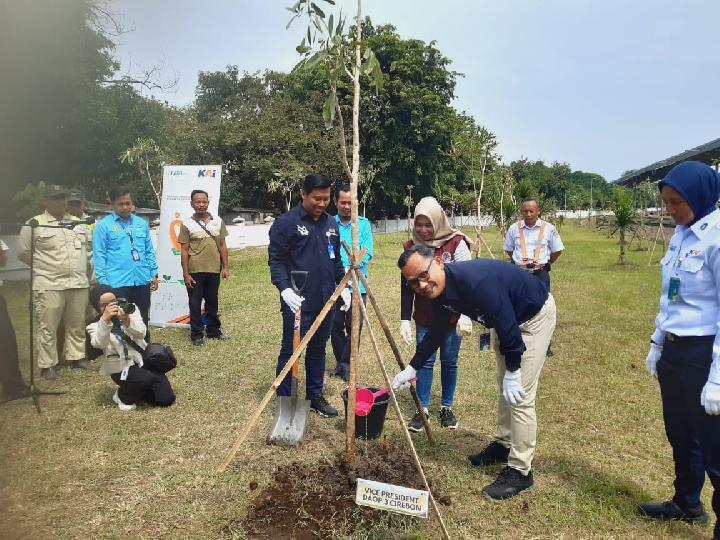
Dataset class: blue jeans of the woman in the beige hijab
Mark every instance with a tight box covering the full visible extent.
[415,324,462,407]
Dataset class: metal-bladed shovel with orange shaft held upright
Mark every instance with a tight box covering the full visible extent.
[267,270,310,446]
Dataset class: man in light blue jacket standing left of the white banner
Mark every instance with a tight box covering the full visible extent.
[93,186,158,342]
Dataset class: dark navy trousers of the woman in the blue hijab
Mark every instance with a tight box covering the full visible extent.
[657,336,720,537]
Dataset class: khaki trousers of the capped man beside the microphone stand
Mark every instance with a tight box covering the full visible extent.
[33,289,88,369]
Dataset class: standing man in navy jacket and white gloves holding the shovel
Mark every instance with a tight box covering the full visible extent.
[268,174,350,418]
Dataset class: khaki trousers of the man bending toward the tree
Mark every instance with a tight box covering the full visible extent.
[493,294,556,476]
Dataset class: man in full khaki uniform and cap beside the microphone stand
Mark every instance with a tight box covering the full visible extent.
[18,185,91,379]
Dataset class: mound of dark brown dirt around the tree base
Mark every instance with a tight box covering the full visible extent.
[242,443,450,540]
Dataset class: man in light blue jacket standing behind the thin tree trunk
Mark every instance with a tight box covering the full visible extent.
[330,184,373,382]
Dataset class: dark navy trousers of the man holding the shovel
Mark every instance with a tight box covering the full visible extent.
[275,303,335,397]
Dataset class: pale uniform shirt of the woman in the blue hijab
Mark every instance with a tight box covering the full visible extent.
[651,210,720,384]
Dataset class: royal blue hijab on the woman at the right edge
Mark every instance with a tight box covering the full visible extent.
[658,161,720,225]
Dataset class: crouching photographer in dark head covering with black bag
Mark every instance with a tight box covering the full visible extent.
[86,285,176,411]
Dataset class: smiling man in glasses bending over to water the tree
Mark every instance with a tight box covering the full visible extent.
[393,245,555,500]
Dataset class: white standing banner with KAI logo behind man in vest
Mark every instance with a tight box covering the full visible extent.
[150,165,222,327]
